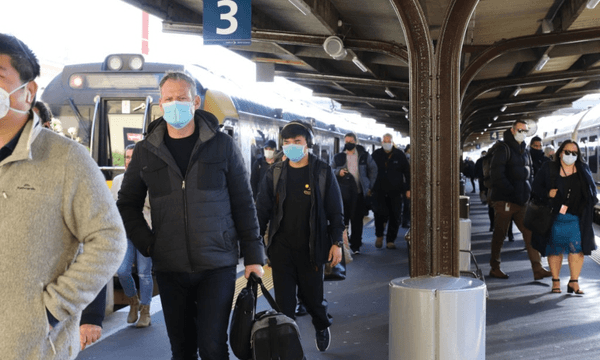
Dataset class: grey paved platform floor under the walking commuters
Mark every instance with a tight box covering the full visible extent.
[78,194,600,360]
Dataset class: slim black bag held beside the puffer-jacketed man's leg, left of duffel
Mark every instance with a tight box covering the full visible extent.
[229,276,258,360]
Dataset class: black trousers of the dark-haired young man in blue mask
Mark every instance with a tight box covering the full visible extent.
[269,239,331,330]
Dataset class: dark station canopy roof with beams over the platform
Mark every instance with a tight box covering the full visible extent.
[124,0,600,146]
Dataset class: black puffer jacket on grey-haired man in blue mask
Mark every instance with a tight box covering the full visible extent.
[117,110,264,273]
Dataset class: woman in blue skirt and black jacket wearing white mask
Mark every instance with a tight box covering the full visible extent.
[532,140,598,295]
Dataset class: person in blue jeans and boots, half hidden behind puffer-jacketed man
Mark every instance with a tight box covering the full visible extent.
[110,144,154,327]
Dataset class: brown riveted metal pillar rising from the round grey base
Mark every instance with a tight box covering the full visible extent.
[390,0,478,277]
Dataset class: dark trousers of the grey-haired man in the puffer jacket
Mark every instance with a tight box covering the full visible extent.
[155,266,235,360]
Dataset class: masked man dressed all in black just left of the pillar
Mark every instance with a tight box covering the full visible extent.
[373,134,410,249]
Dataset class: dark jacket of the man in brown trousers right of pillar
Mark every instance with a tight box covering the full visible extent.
[490,129,533,206]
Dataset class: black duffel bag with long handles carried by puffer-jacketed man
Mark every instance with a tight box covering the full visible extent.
[250,273,305,360]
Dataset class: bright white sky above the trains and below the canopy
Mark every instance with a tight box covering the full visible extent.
[0,0,400,139]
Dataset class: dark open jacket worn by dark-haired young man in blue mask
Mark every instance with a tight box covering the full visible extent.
[256,154,344,266]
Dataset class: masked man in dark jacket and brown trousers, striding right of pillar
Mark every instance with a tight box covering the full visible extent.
[490,120,552,280]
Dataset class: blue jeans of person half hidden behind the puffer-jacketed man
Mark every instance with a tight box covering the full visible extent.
[117,240,154,305]
